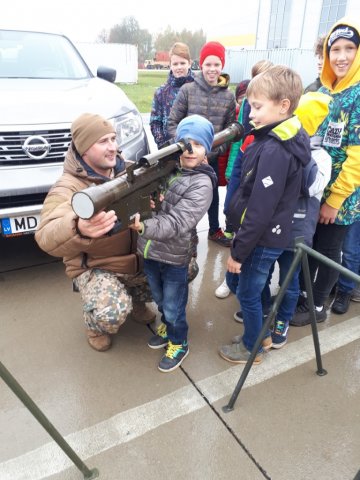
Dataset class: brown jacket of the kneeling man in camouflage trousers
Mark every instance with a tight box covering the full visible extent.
[35,146,140,278]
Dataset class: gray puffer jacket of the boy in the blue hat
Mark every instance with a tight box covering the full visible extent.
[138,165,217,265]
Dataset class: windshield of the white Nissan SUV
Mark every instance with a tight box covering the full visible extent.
[0,30,92,79]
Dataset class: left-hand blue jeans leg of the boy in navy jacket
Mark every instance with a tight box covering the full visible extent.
[236,247,283,351]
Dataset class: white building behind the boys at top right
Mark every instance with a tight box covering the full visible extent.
[224,0,360,86]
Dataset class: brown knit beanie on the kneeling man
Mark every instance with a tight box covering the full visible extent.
[71,113,116,156]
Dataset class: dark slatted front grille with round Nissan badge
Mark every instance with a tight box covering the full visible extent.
[0,129,71,166]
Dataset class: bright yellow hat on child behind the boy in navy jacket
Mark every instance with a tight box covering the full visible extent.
[294,92,331,137]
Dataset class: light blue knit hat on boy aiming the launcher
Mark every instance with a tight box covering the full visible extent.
[175,115,214,153]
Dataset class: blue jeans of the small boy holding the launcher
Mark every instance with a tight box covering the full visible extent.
[144,259,189,345]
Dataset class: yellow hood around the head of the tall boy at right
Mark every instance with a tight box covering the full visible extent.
[320,17,360,93]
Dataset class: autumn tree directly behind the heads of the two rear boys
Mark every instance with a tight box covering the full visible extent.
[154,26,206,60]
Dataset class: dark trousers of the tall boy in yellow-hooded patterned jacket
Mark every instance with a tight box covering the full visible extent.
[309,223,350,307]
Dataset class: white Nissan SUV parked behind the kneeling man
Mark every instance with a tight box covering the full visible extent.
[0,30,149,237]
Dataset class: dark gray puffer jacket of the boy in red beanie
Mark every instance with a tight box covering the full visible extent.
[167,72,236,161]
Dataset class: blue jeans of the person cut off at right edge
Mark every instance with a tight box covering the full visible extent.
[338,221,360,293]
